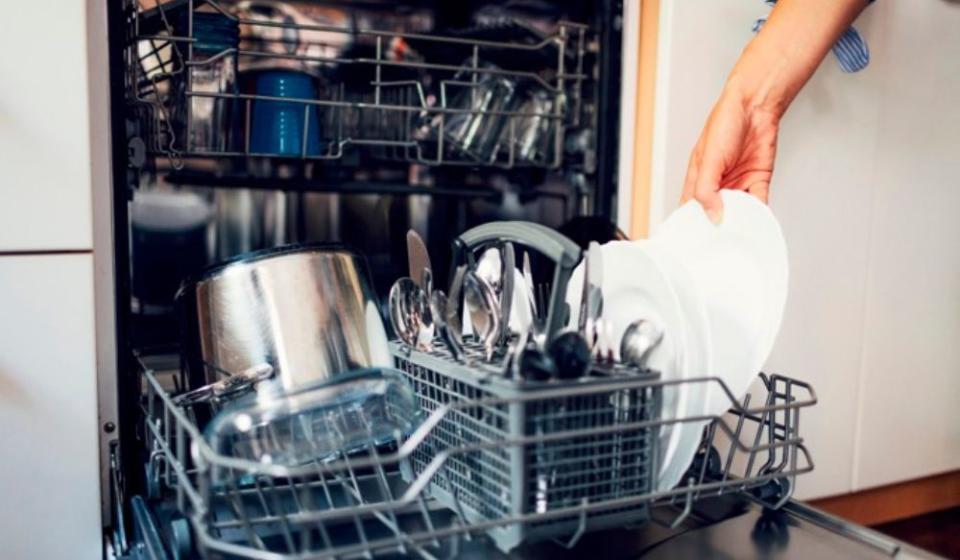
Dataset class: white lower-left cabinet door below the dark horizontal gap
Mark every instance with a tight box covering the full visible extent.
[0,254,102,560]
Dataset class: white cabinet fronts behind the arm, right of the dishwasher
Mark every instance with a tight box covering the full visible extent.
[650,0,960,497]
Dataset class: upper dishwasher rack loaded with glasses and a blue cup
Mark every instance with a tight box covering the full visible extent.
[125,0,596,168]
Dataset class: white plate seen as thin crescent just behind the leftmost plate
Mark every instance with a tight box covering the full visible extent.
[638,241,713,491]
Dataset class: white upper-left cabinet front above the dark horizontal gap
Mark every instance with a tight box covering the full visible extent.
[0,0,94,252]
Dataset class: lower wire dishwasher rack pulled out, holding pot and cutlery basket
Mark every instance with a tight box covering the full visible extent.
[131,348,817,560]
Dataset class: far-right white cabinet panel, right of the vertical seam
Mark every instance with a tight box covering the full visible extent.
[855,2,960,488]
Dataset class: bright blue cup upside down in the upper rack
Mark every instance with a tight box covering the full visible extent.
[250,70,320,156]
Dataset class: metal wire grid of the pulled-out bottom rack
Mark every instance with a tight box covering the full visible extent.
[141,348,816,559]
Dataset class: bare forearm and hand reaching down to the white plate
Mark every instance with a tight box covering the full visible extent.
[681,0,867,222]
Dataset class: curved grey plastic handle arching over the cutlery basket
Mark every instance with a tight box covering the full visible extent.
[453,221,581,340]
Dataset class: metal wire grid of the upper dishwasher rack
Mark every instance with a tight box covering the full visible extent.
[126,0,589,168]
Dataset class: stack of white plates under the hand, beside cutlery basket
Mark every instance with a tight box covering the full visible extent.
[567,191,787,490]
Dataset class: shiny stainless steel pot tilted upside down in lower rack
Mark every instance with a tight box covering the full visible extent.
[177,245,392,400]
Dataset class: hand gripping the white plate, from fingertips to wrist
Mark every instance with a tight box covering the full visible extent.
[681,87,780,223]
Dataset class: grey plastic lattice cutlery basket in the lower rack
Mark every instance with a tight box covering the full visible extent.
[392,343,661,551]
